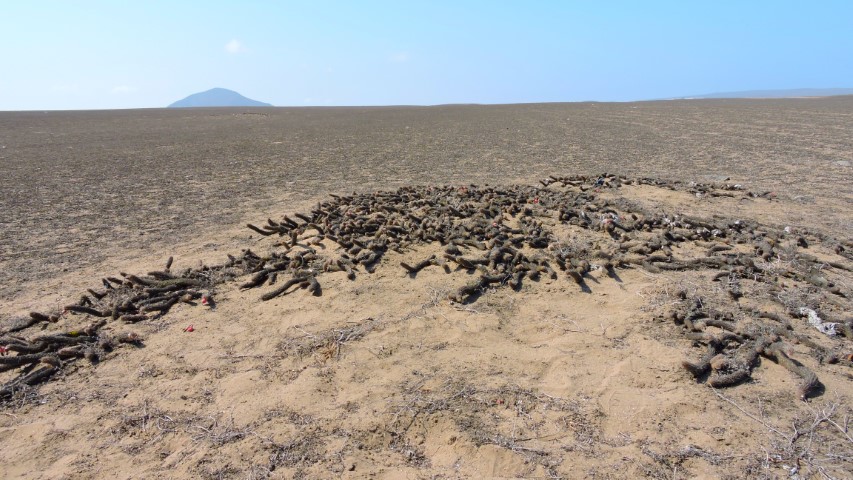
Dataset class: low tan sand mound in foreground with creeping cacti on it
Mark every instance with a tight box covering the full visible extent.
[0,175,853,478]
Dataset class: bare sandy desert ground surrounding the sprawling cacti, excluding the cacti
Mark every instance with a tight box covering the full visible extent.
[0,97,853,479]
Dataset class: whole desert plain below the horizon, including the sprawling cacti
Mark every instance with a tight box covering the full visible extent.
[0,97,853,479]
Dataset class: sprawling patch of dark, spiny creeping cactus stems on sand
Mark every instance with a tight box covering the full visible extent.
[0,174,853,399]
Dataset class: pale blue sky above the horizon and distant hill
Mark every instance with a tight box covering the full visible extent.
[0,0,853,110]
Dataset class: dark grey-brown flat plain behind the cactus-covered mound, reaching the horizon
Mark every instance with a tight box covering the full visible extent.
[0,96,853,300]
